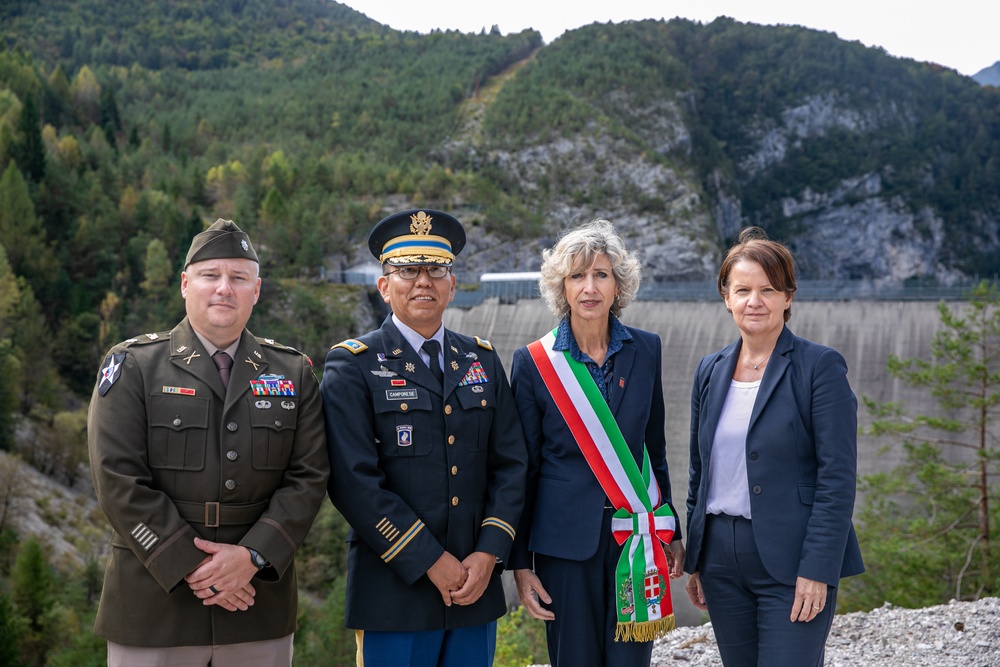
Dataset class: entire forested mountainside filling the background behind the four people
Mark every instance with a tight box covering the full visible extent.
[0,0,1000,664]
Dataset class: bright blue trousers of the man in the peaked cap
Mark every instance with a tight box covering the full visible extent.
[356,621,497,667]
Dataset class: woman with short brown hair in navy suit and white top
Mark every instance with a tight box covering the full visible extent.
[686,227,864,667]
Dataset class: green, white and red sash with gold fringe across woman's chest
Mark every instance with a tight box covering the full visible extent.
[528,330,676,642]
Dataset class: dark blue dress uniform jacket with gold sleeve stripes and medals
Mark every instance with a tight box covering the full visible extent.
[321,315,525,631]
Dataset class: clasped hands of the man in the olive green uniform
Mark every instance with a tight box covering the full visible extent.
[184,537,257,611]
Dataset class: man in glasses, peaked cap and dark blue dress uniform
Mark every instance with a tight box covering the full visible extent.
[322,210,526,667]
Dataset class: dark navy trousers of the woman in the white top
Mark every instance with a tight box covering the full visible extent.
[698,514,837,667]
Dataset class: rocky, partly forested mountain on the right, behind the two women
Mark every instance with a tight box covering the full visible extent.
[459,19,1000,281]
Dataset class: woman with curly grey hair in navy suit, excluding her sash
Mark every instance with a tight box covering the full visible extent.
[508,220,684,667]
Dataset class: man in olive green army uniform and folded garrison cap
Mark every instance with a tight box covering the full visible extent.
[88,220,329,667]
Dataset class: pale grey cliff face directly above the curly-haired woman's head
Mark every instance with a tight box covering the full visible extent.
[449,93,718,281]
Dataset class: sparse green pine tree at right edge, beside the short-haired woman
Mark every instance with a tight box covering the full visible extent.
[845,282,1000,608]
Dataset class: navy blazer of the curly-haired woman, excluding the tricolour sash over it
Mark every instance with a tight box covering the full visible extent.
[508,327,679,569]
